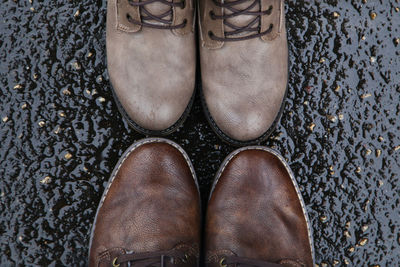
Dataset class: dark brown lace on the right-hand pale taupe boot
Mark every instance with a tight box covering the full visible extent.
[208,0,273,42]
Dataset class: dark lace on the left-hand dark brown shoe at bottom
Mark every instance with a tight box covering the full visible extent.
[112,250,188,267]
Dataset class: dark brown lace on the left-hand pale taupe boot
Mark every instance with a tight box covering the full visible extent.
[127,0,187,30]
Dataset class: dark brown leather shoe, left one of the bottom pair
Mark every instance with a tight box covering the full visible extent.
[89,138,201,267]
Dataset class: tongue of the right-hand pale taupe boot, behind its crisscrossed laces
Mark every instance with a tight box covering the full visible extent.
[222,0,261,38]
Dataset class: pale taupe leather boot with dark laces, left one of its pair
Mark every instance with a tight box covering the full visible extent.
[107,0,196,135]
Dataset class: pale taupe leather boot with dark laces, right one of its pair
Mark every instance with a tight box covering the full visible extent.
[199,0,288,145]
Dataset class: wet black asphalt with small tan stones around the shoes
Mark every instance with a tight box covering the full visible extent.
[0,0,400,267]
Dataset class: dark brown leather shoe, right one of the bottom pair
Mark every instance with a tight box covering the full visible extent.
[205,147,314,267]
